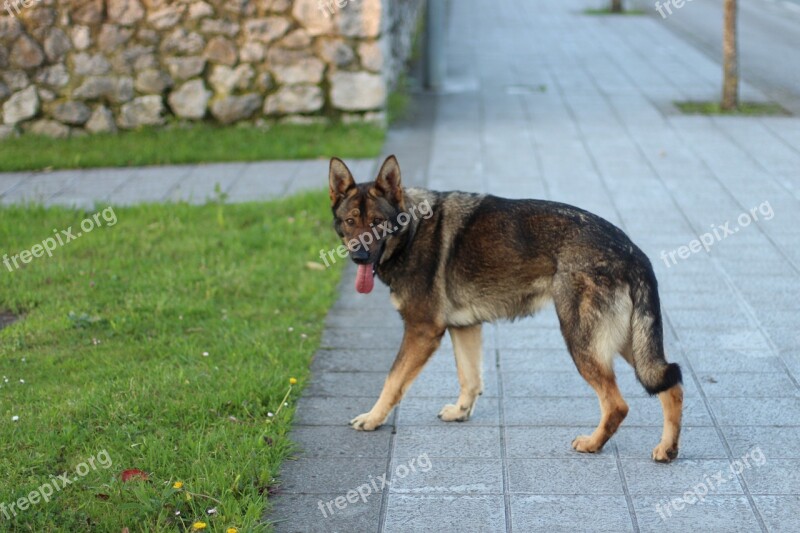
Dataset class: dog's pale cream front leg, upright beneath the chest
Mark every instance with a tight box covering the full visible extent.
[439,324,483,422]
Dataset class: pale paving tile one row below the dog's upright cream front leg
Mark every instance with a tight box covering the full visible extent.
[394,422,500,459]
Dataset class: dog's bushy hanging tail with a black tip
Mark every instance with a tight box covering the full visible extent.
[631,264,683,395]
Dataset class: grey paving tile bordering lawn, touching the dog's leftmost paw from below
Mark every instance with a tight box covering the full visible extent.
[290,425,391,458]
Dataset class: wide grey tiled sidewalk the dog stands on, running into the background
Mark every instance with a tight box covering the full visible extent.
[268,0,800,532]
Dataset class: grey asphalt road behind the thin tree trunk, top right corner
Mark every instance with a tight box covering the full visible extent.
[633,0,800,114]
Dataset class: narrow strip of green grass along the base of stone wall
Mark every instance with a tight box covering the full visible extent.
[0,123,385,171]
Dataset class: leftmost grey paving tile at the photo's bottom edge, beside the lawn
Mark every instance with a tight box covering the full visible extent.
[269,493,381,533]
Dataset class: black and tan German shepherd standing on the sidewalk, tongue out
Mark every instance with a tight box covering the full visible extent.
[329,156,683,462]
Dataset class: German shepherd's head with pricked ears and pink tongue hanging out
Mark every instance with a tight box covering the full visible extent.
[328,156,405,293]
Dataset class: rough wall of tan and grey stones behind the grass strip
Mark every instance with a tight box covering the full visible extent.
[0,0,424,138]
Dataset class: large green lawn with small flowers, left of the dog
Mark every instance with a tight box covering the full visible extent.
[0,192,340,532]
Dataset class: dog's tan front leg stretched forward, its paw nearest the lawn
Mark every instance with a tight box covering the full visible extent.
[350,323,445,431]
